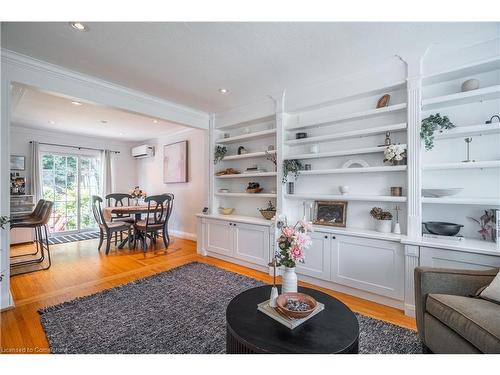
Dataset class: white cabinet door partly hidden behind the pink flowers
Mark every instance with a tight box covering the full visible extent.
[296,232,332,280]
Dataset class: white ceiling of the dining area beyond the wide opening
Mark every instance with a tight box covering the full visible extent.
[11,85,186,142]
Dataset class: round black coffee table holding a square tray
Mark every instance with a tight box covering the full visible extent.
[226,285,359,354]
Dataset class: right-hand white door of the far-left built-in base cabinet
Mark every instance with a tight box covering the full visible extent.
[233,223,269,266]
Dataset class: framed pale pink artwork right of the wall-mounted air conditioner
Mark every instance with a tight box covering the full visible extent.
[163,141,188,184]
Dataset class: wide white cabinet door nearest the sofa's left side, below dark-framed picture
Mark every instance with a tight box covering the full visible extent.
[331,235,404,299]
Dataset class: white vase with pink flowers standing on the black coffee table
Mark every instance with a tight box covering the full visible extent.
[275,217,312,293]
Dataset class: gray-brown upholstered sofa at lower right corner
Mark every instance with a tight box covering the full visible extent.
[415,267,500,353]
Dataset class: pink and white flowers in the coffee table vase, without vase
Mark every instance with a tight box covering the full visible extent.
[276,221,312,267]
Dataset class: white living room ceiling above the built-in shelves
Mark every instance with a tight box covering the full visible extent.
[2,22,499,112]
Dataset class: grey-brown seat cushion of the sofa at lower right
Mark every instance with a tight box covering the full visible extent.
[425,294,500,353]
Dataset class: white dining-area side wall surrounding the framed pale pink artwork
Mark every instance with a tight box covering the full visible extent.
[137,129,209,239]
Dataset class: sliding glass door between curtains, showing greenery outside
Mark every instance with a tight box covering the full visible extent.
[41,152,101,233]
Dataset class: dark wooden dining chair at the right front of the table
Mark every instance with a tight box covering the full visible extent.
[134,194,173,251]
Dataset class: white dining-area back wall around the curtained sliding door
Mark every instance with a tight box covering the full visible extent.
[10,124,138,192]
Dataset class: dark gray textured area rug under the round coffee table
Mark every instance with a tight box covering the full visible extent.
[39,263,421,354]
